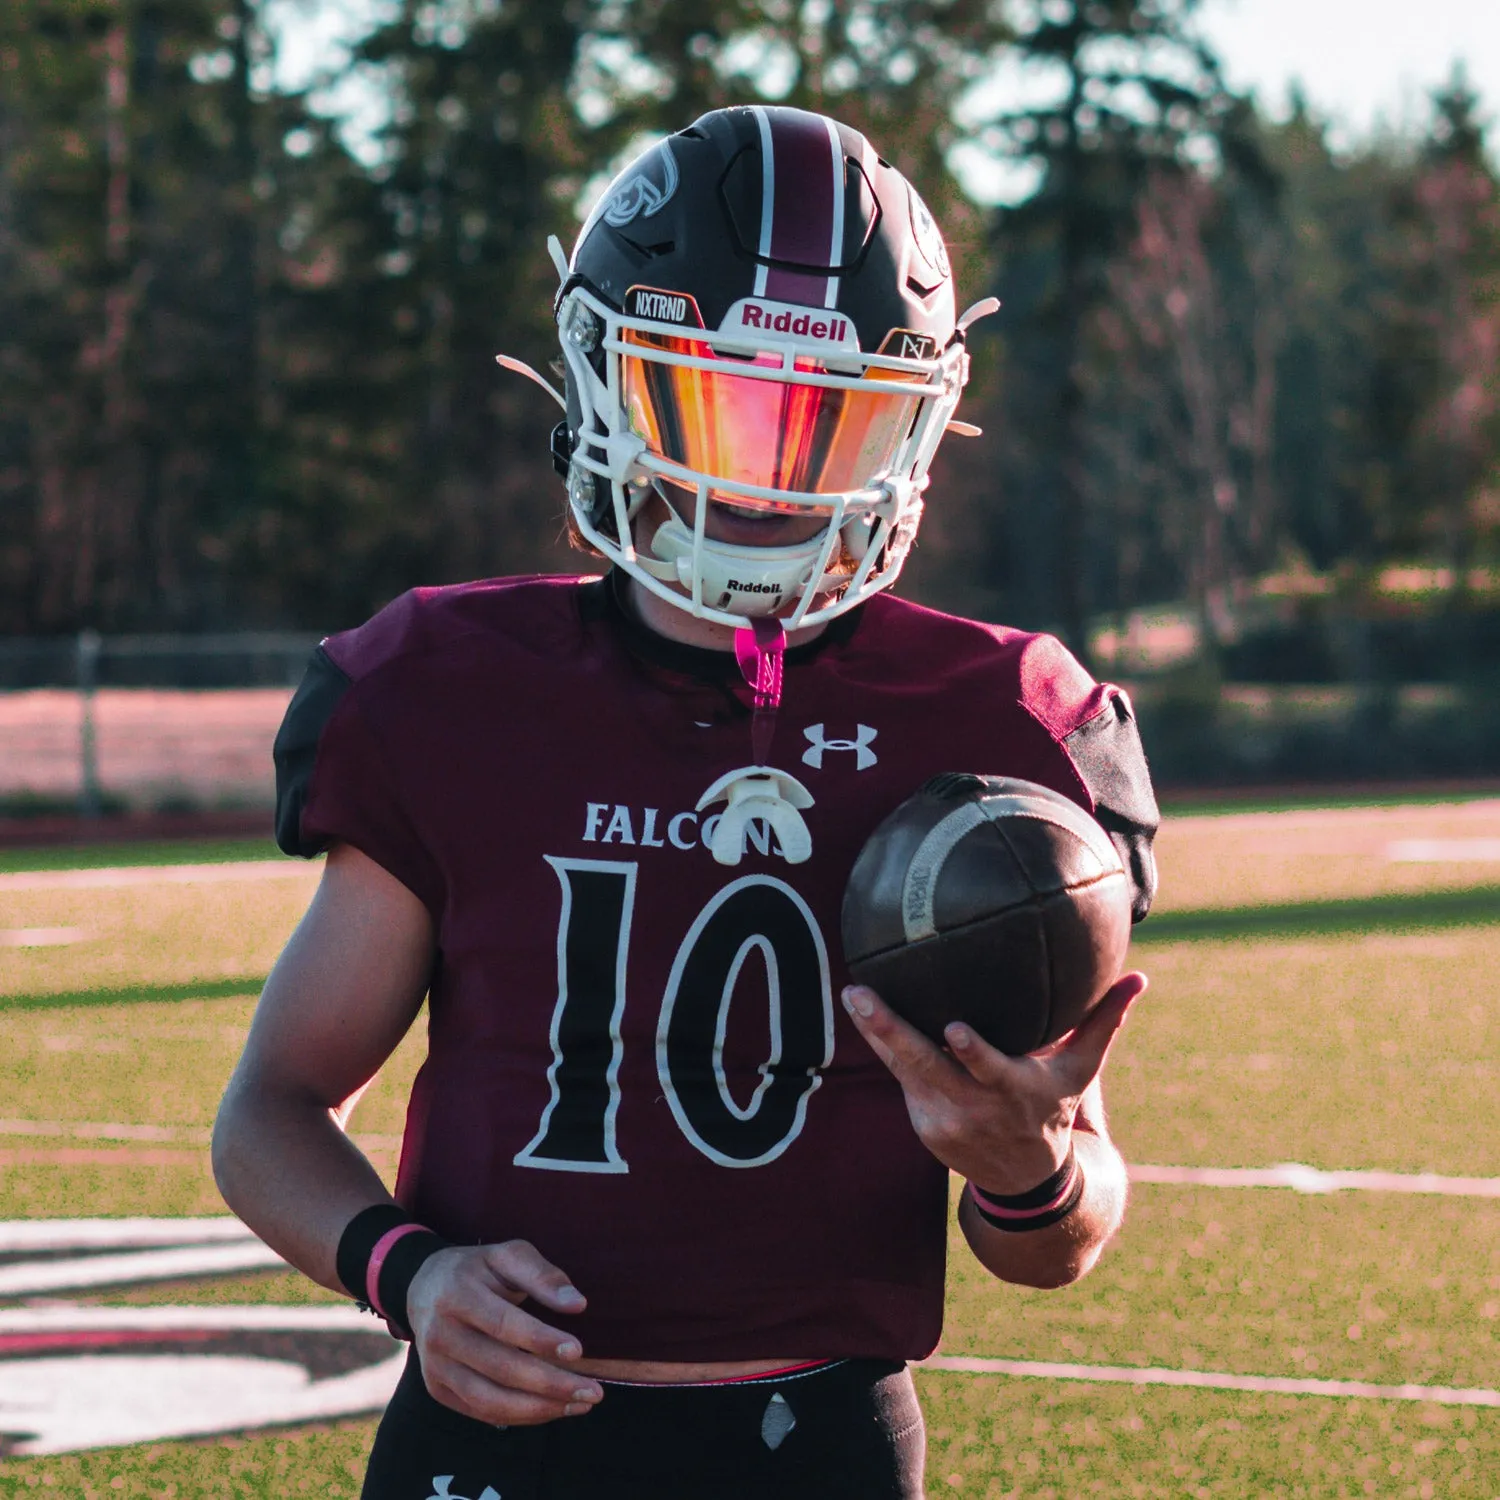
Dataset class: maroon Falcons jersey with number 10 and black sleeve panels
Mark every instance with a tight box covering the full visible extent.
[276,579,1157,1361]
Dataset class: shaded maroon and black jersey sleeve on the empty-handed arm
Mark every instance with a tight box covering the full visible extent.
[272,647,443,917]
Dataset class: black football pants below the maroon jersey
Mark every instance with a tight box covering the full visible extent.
[363,1358,926,1500]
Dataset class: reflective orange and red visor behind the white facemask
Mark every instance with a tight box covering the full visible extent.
[621,329,924,504]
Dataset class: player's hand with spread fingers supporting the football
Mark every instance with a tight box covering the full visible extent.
[843,974,1146,1193]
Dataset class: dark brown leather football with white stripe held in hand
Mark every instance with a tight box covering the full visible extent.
[843,773,1131,1055]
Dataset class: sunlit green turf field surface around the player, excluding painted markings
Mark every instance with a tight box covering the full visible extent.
[0,804,1500,1500]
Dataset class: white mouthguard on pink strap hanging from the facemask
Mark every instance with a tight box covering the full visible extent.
[698,618,813,864]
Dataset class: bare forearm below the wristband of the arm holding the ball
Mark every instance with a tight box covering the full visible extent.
[959,1127,1125,1287]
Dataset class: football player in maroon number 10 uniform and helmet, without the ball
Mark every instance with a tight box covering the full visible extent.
[215,107,1157,1500]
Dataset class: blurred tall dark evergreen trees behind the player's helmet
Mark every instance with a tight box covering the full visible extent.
[0,0,1500,780]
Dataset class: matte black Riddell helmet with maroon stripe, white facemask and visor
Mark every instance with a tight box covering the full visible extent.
[554,105,989,627]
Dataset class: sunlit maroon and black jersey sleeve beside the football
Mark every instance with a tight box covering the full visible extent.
[1020,636,1161,923]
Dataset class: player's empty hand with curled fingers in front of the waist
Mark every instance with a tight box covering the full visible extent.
[407,1239,605,1427]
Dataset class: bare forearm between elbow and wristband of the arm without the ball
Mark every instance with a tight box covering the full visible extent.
[213,1079,392,1292]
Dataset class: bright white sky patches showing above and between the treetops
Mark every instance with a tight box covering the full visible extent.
[267,0,1500,189]
